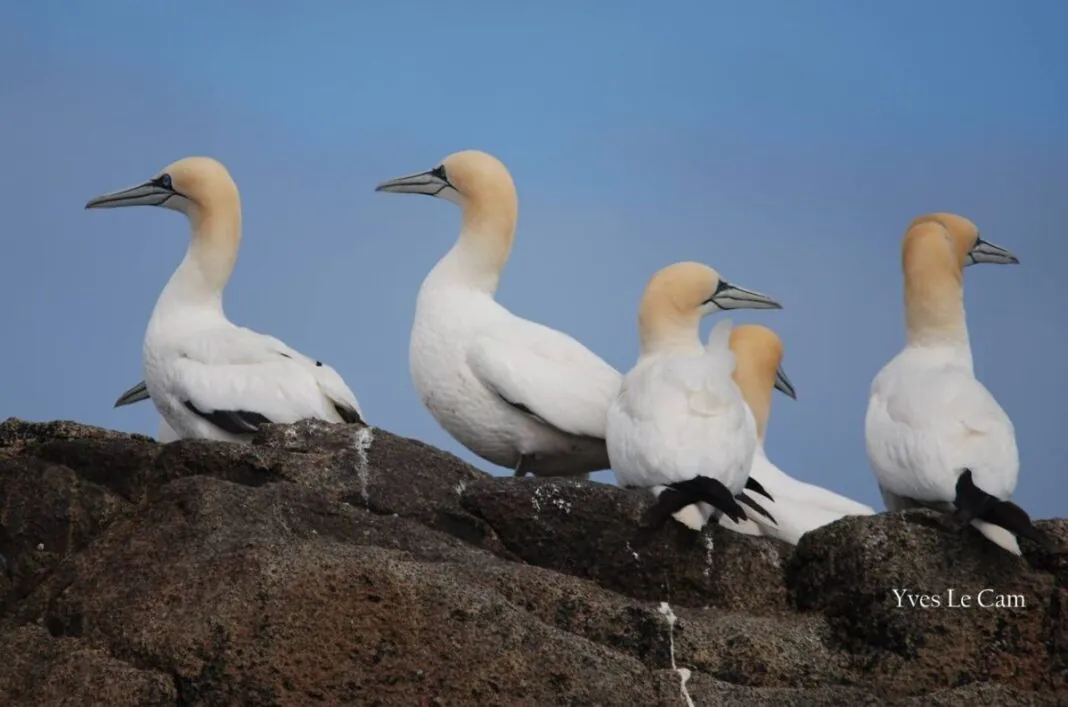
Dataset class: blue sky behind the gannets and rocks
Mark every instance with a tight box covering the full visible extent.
[0,0,1068,517]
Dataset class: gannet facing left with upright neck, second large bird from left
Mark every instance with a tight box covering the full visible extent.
[375,151,621,476]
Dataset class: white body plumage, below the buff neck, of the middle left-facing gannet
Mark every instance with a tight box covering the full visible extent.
[409,253,621,475]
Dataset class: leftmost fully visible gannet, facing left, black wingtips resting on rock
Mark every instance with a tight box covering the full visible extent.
[85,157,363,441]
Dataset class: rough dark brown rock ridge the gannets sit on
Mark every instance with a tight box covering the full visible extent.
[0,419,1068,707]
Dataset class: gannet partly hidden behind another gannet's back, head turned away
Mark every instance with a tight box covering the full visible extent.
[717,324,875,545]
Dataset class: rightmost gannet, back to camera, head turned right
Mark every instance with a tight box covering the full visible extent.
[865,214,1049,554]
